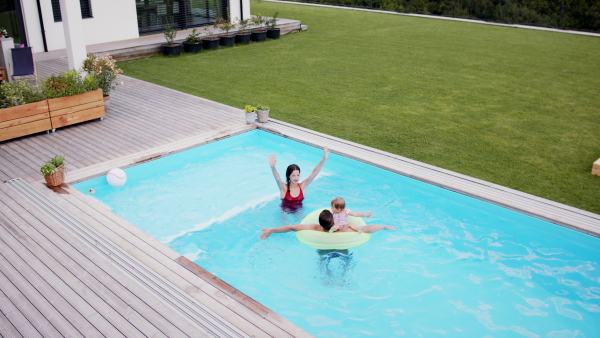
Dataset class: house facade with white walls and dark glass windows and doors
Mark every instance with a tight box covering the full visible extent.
[0,0,250,52]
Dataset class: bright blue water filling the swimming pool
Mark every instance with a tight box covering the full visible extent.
[75,130,600,337]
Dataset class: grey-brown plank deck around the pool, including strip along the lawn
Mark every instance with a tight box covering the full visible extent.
[0,31,600,337]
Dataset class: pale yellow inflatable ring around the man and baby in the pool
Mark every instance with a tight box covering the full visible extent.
[296,208,371,250]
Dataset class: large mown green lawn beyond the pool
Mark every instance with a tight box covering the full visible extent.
[120,2,600,213]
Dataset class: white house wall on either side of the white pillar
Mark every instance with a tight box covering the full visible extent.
[21,0,139,52]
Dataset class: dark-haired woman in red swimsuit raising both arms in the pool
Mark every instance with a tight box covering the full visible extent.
[269,147,329,213]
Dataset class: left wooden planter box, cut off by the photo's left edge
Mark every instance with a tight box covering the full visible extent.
[0,100,52,141]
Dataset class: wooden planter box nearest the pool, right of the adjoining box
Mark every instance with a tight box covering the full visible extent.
[48,89,106,129]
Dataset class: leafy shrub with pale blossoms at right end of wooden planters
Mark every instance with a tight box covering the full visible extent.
[83,53,123,109]
